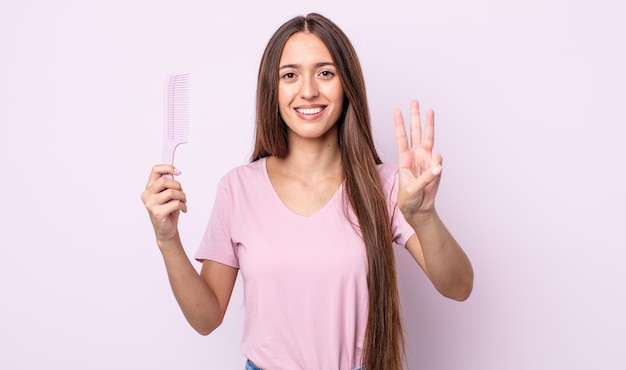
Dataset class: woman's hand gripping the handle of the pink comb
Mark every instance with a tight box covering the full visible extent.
[141,164,187,246]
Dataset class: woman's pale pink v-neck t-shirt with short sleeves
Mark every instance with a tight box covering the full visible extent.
[196,158,414,370]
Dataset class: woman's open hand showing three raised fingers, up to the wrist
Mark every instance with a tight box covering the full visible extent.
[394,100,442,222]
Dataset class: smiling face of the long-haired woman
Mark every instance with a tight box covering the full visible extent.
[278,32,343,142]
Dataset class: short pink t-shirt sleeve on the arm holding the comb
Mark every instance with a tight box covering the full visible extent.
[195,177,239,268]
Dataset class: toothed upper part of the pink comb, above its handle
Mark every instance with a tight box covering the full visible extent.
[166,73,190,144]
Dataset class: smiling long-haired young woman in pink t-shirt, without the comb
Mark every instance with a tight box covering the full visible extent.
[142,14,473,370]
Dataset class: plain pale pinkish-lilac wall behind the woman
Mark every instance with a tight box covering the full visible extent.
[0,0,626,370]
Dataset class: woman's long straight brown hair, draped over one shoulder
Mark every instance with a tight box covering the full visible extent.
[251,13,404,370]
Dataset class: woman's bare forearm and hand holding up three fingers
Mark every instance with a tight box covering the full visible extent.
[394,101,474,300]
